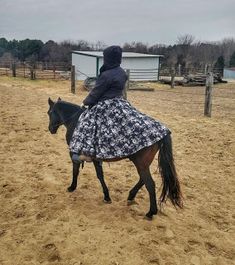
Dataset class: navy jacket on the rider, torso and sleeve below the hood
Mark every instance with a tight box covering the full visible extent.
[83,66,127,106]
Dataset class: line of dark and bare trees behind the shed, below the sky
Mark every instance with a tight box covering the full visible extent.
[0,34,235,69]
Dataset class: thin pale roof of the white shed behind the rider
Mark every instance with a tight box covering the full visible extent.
[72,51,163,58]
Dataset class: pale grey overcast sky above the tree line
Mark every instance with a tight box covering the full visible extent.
[0,0,235,45]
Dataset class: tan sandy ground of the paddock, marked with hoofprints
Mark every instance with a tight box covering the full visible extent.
[0,77,235,265]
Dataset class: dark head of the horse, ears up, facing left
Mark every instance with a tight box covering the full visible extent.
[47,98,63,134]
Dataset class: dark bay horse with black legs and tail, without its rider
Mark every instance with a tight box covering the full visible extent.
[48,98,183,218]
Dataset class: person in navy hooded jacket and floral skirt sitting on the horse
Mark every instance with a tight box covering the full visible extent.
[70,46,170,162]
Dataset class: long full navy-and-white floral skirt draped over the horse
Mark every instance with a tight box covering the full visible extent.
[70,98,170,160]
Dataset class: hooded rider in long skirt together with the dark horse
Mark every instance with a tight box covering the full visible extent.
[48,46,183,219]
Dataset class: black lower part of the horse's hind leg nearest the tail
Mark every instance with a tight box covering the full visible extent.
[138,168,158,219]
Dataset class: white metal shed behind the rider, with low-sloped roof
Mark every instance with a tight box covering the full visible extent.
[72,51,163,81]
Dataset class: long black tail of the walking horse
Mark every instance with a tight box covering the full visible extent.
[158,134,183,208]
